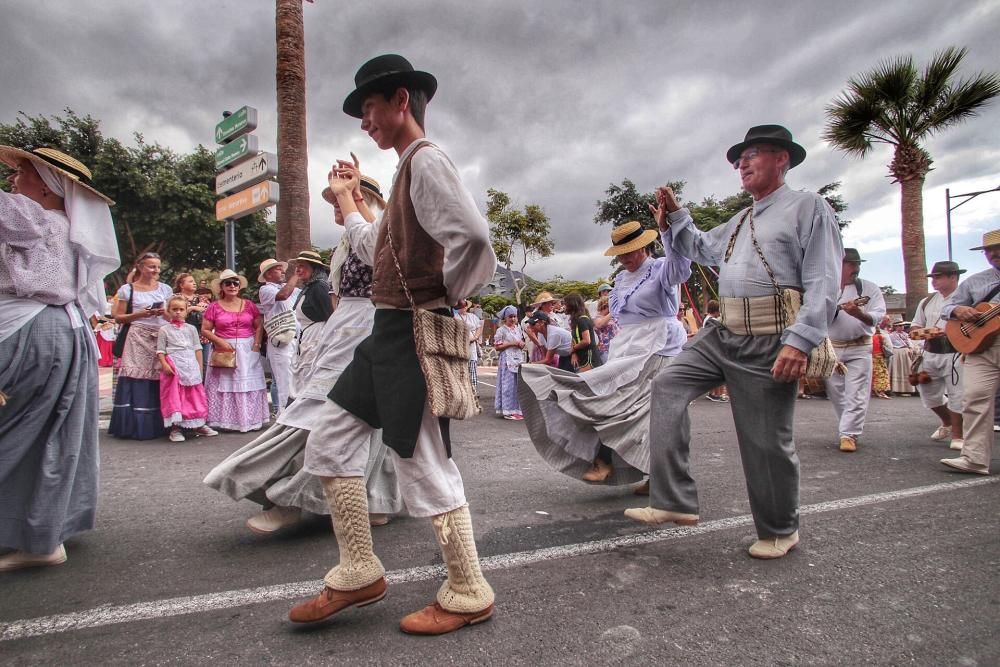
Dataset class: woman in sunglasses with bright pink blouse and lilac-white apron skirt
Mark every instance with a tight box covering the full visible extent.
[201,269,270,433]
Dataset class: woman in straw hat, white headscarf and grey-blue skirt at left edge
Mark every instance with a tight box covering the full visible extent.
[0,146,119,572]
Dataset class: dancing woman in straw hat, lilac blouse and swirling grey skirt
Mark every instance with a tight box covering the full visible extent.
[518,221,691,484]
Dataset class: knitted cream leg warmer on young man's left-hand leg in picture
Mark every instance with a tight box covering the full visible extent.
[321,477,385,591]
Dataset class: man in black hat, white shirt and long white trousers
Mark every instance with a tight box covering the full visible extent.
[826,248,885,452]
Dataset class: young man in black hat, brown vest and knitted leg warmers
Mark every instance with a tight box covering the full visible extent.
[289,55,496,635]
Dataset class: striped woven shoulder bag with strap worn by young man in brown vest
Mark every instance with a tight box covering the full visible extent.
[386,221,482,419]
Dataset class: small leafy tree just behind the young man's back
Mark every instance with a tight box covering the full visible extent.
[486,188,555,303]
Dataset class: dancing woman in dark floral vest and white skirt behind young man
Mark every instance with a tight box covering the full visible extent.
[205,168,402,534]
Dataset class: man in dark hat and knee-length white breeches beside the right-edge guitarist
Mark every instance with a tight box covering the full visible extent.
[910,262,965,449]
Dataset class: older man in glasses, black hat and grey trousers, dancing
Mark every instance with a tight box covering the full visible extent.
[625,125,843,558]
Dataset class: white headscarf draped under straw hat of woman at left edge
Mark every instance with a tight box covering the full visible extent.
[32,161,121,317]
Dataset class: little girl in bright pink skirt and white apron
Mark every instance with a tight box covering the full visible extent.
[156,296,219,442]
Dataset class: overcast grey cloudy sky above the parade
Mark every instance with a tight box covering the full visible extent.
[0,0,1000,291]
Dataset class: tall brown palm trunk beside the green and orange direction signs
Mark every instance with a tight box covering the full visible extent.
[274,0,312,259]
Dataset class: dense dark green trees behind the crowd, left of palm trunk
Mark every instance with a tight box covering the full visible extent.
[0,109,274,288]
